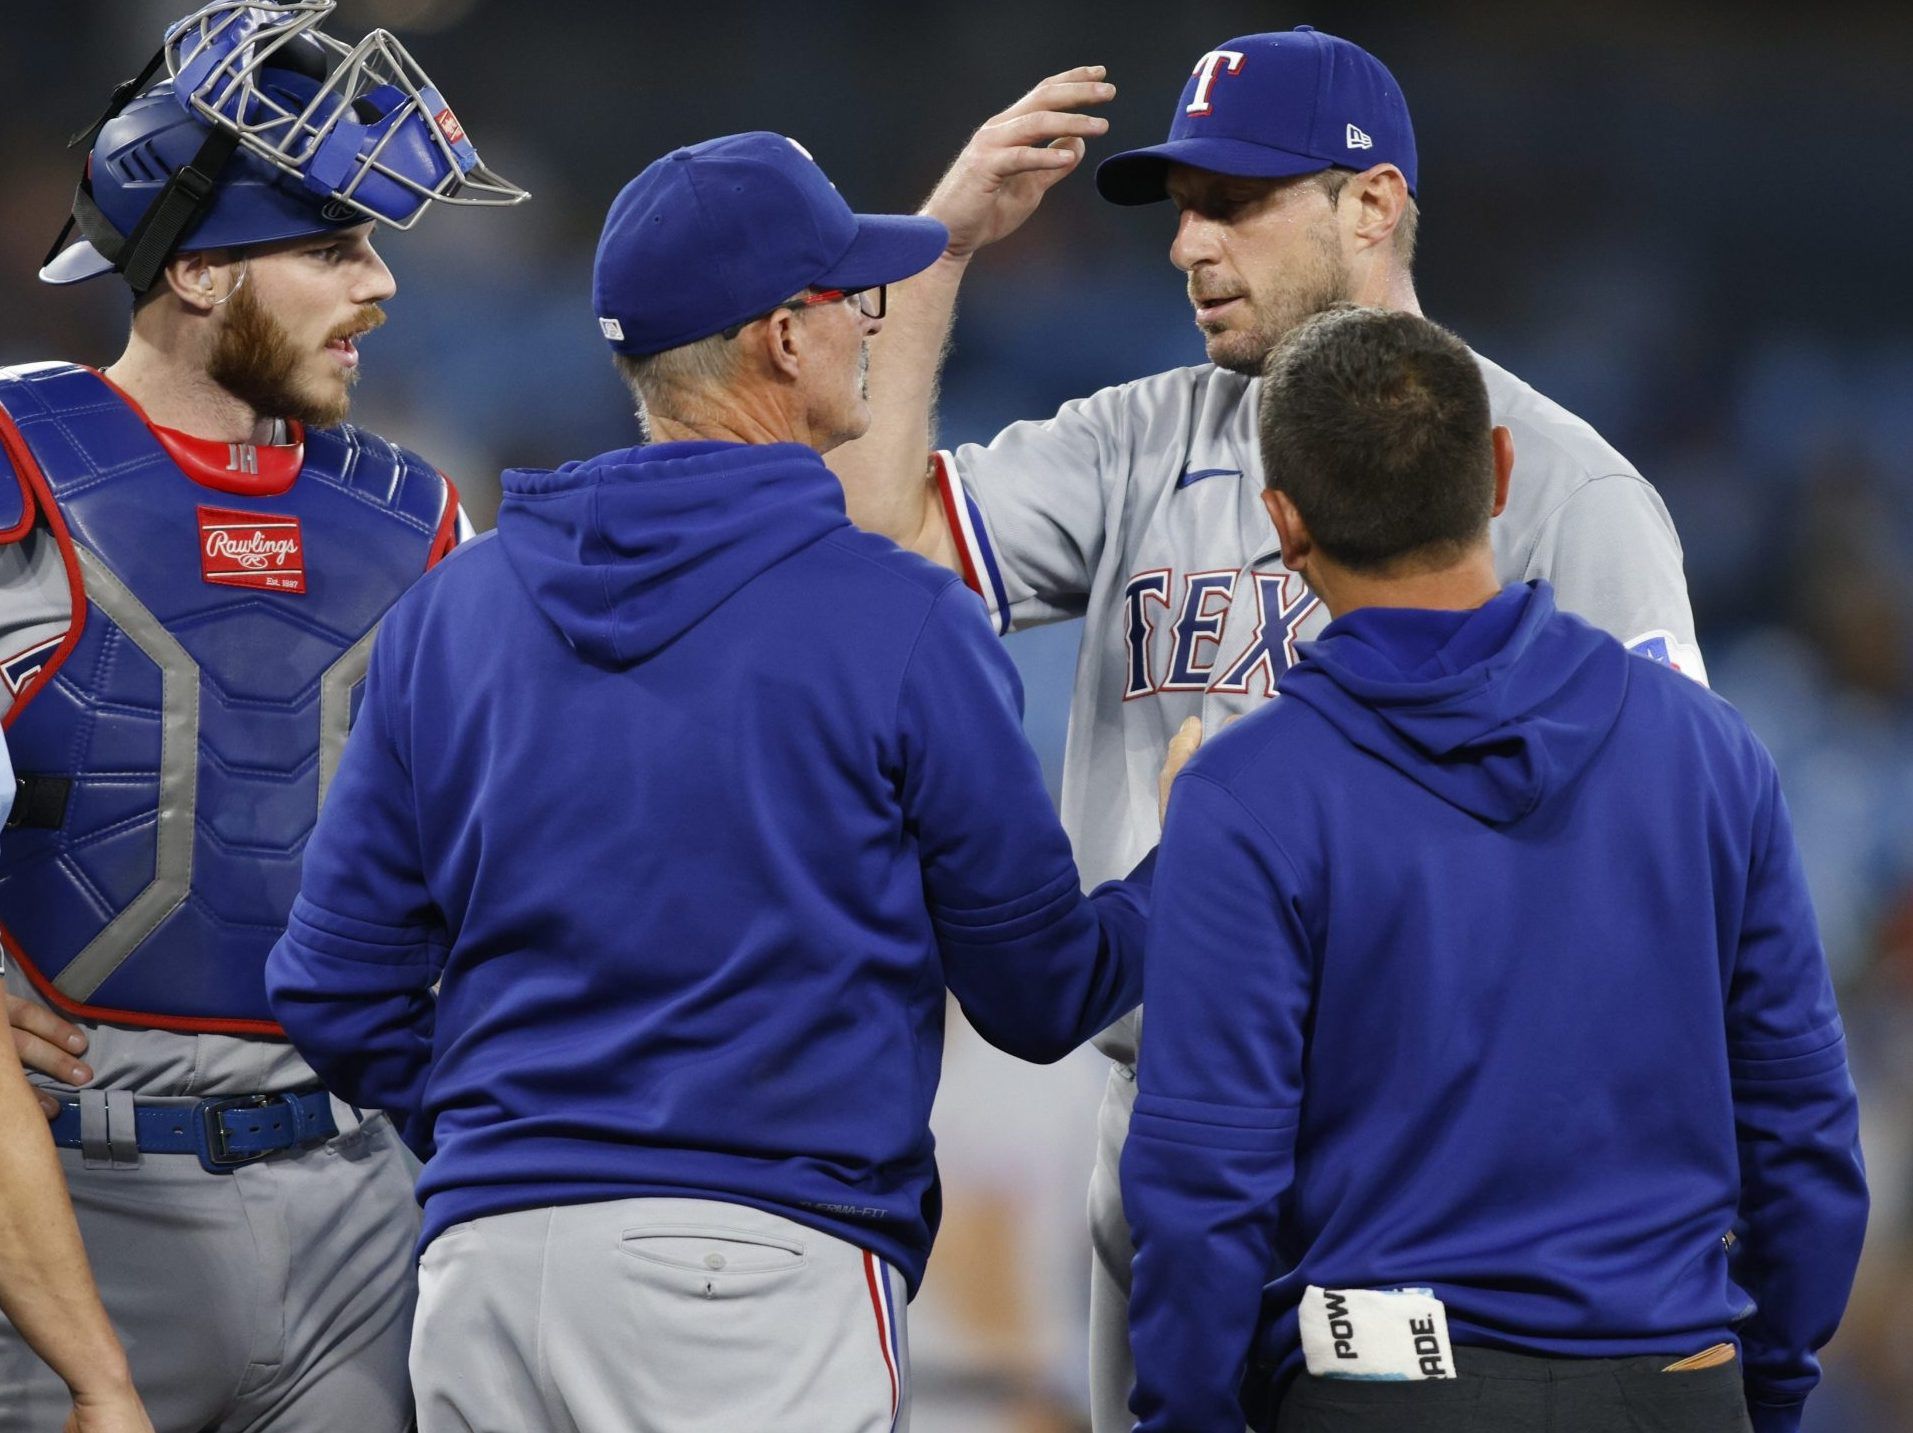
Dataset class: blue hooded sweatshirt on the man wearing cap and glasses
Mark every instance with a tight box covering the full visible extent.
[268,442,1146,1290]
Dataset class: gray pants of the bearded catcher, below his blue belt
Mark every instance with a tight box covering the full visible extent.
[0,1106,419,1433]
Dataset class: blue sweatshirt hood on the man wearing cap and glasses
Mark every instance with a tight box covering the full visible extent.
[497,442,849,668]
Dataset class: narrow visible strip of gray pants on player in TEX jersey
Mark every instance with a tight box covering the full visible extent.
[1088,1064,1136,1433]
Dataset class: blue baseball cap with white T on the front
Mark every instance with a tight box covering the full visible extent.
[1096,25,1416,205]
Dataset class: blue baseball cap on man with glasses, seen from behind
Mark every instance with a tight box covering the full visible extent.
[591,130,949,354]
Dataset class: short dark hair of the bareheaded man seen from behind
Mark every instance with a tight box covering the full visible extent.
[1259,304,1494,572]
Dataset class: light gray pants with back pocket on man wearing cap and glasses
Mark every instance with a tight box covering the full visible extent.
[411,1200,909,1433]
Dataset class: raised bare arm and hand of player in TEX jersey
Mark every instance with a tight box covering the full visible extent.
[825,65,1115,568]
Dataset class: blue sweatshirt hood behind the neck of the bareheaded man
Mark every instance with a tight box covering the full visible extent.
[1282,582,1630,825]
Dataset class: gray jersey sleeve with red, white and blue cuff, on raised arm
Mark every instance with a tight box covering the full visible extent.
[934,388,1131,633]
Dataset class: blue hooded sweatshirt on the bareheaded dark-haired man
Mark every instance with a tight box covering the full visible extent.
[1123,584,1867,1433]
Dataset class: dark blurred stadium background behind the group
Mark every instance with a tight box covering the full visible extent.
[0,0,1913,1433]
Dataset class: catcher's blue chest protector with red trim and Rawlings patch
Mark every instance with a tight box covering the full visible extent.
[0,364,455,1035]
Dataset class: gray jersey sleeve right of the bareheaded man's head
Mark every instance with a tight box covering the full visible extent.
[1517,472,1706,687]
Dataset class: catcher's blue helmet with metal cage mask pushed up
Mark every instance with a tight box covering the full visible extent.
[40,0,526,293]
